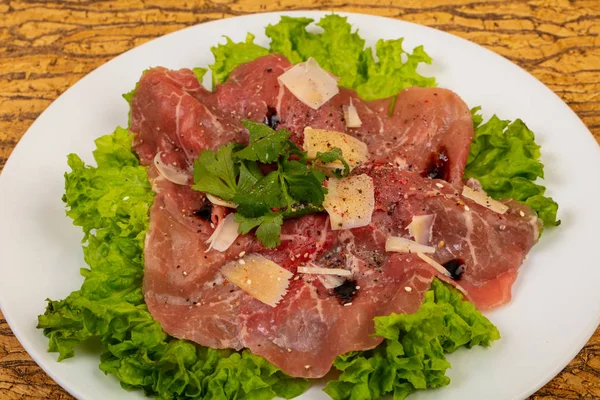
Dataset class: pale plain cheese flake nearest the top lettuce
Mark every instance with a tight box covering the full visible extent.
[277,57,340,110]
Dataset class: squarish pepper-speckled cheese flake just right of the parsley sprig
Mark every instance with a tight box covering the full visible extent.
[323,174,375,230]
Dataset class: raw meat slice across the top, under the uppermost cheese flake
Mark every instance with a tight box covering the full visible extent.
[216,54,473,182]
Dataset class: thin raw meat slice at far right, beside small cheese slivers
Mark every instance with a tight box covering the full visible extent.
[356,164,539,310]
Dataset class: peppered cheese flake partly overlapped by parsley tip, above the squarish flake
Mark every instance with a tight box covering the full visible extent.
[304,126,369,170]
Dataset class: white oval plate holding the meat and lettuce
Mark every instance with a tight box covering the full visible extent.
[0,12,600,400]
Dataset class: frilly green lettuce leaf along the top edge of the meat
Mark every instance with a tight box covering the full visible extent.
[211,14,436,100]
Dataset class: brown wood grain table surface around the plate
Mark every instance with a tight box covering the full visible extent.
[0,0,600,400]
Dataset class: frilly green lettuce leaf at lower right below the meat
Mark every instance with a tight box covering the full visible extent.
[325,279,500,400]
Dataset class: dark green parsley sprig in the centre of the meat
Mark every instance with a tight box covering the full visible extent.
[192,121,349,248]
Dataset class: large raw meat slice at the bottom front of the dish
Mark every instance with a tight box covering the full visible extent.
[144,167,435,377]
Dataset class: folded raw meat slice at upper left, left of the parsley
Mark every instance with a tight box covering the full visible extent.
[131,68,248,169]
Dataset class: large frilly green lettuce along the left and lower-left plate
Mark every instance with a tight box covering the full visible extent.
[38,128,308,400]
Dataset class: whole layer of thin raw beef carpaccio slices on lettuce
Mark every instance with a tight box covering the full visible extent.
[131,55,538,378]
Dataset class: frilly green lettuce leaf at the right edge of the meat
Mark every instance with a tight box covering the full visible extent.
[465,107,560,226]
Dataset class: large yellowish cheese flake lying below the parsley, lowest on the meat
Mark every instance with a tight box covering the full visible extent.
[221,254,293,307]
